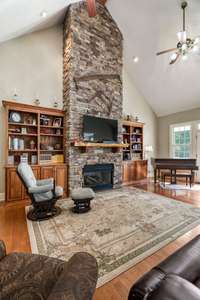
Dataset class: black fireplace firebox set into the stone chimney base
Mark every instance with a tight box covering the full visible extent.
[83,164,114,190]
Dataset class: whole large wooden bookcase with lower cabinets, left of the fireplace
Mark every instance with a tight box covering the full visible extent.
[2,101,67,201]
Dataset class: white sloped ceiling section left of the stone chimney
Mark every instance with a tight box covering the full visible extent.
[0,0,77,43]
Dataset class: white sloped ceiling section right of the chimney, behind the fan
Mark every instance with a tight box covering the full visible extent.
[108,0,200,116]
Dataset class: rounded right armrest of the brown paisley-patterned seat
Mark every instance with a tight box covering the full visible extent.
[48,252,98,300]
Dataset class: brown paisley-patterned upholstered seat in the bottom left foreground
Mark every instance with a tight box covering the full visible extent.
[0,241,97,300]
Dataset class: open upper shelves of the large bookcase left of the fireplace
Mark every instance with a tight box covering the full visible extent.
[3,101,65,165]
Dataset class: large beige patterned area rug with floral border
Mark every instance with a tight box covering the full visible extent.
[27,187,200,286]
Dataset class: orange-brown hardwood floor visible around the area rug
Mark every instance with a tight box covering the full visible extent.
[0,180,200,300]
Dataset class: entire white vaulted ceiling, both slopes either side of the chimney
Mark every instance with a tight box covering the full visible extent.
[0,0,200,116]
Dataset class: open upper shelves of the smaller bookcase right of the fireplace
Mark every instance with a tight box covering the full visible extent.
[122,121,144,160]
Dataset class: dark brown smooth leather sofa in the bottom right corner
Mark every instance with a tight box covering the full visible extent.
[128,235,200,300]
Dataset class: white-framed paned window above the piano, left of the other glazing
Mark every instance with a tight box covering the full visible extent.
[171,124,192,158]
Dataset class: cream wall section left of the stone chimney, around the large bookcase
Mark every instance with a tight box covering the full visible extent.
[0,26,63,198]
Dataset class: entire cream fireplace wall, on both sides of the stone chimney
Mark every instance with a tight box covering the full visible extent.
[0,26,157,198]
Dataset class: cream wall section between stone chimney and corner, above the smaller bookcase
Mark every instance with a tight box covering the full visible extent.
[123,68,157,172]
